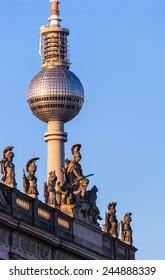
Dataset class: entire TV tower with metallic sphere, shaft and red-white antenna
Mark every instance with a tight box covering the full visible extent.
[27,0,84,180]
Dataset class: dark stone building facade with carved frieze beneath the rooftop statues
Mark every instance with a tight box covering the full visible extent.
[0,183,136,260]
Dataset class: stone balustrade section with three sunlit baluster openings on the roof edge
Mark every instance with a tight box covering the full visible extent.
[0,183,73,240]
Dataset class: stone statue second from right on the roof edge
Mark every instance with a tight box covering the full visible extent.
[103,202,119,238]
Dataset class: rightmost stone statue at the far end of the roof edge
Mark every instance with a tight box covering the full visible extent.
[121,212,133,245]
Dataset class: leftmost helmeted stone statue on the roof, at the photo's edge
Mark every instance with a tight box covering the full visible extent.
[0,146,17,188]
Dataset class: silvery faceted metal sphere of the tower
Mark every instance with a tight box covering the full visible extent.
[27,66,84,123]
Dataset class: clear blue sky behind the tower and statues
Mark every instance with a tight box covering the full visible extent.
[0,0,165,259]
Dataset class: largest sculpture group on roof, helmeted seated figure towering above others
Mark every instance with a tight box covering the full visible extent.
[56,144,101,226]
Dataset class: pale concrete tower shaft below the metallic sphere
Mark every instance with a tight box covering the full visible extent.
[44,121,67,181]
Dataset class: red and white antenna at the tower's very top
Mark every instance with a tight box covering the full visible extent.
[49,0,61,27]
